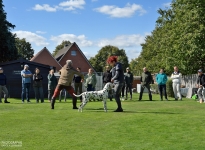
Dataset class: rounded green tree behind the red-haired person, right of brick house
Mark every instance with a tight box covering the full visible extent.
[89,45,129,72]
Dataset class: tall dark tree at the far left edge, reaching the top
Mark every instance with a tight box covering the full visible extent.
[0,0,18,63]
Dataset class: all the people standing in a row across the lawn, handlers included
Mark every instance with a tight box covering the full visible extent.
[4,56,205,112]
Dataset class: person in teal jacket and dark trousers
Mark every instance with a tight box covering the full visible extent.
[156,69,168,101]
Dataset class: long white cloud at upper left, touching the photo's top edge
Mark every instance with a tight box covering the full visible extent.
[33,0,85,12]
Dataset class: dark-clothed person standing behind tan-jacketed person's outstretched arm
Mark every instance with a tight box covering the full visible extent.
[73,67,82,102]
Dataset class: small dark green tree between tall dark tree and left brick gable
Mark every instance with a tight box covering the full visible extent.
[15,38,34,60]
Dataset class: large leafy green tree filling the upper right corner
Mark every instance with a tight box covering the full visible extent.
[135,0,205,74]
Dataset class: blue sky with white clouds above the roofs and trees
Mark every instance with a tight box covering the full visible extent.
[3,0,171,60]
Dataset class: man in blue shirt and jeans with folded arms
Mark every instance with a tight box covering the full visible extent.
[21,64,32,103]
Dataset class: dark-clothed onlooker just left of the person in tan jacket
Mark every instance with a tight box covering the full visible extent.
[47,69,58,102]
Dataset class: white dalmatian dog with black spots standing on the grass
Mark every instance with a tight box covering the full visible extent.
[73,82,113,112]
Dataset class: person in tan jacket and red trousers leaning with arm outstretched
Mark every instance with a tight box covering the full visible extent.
[51,60,84,109]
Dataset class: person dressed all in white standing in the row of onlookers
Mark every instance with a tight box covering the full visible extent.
[171,66,182,100]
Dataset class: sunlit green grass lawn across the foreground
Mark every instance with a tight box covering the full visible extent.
[0,94,205,150]
